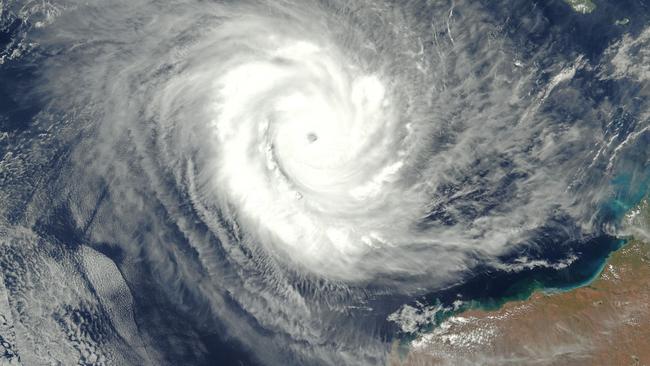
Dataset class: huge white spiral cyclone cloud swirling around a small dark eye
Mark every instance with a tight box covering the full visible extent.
[0,0,648,365]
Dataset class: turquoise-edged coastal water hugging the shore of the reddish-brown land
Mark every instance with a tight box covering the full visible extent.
[403,169,650,338]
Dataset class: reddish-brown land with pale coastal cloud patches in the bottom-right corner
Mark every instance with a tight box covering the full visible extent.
[389,200,650,366]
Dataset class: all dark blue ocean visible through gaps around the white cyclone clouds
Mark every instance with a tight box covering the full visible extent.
[0,0,650,365]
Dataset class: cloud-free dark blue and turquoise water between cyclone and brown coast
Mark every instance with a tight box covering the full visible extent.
[389,173,650,341]
